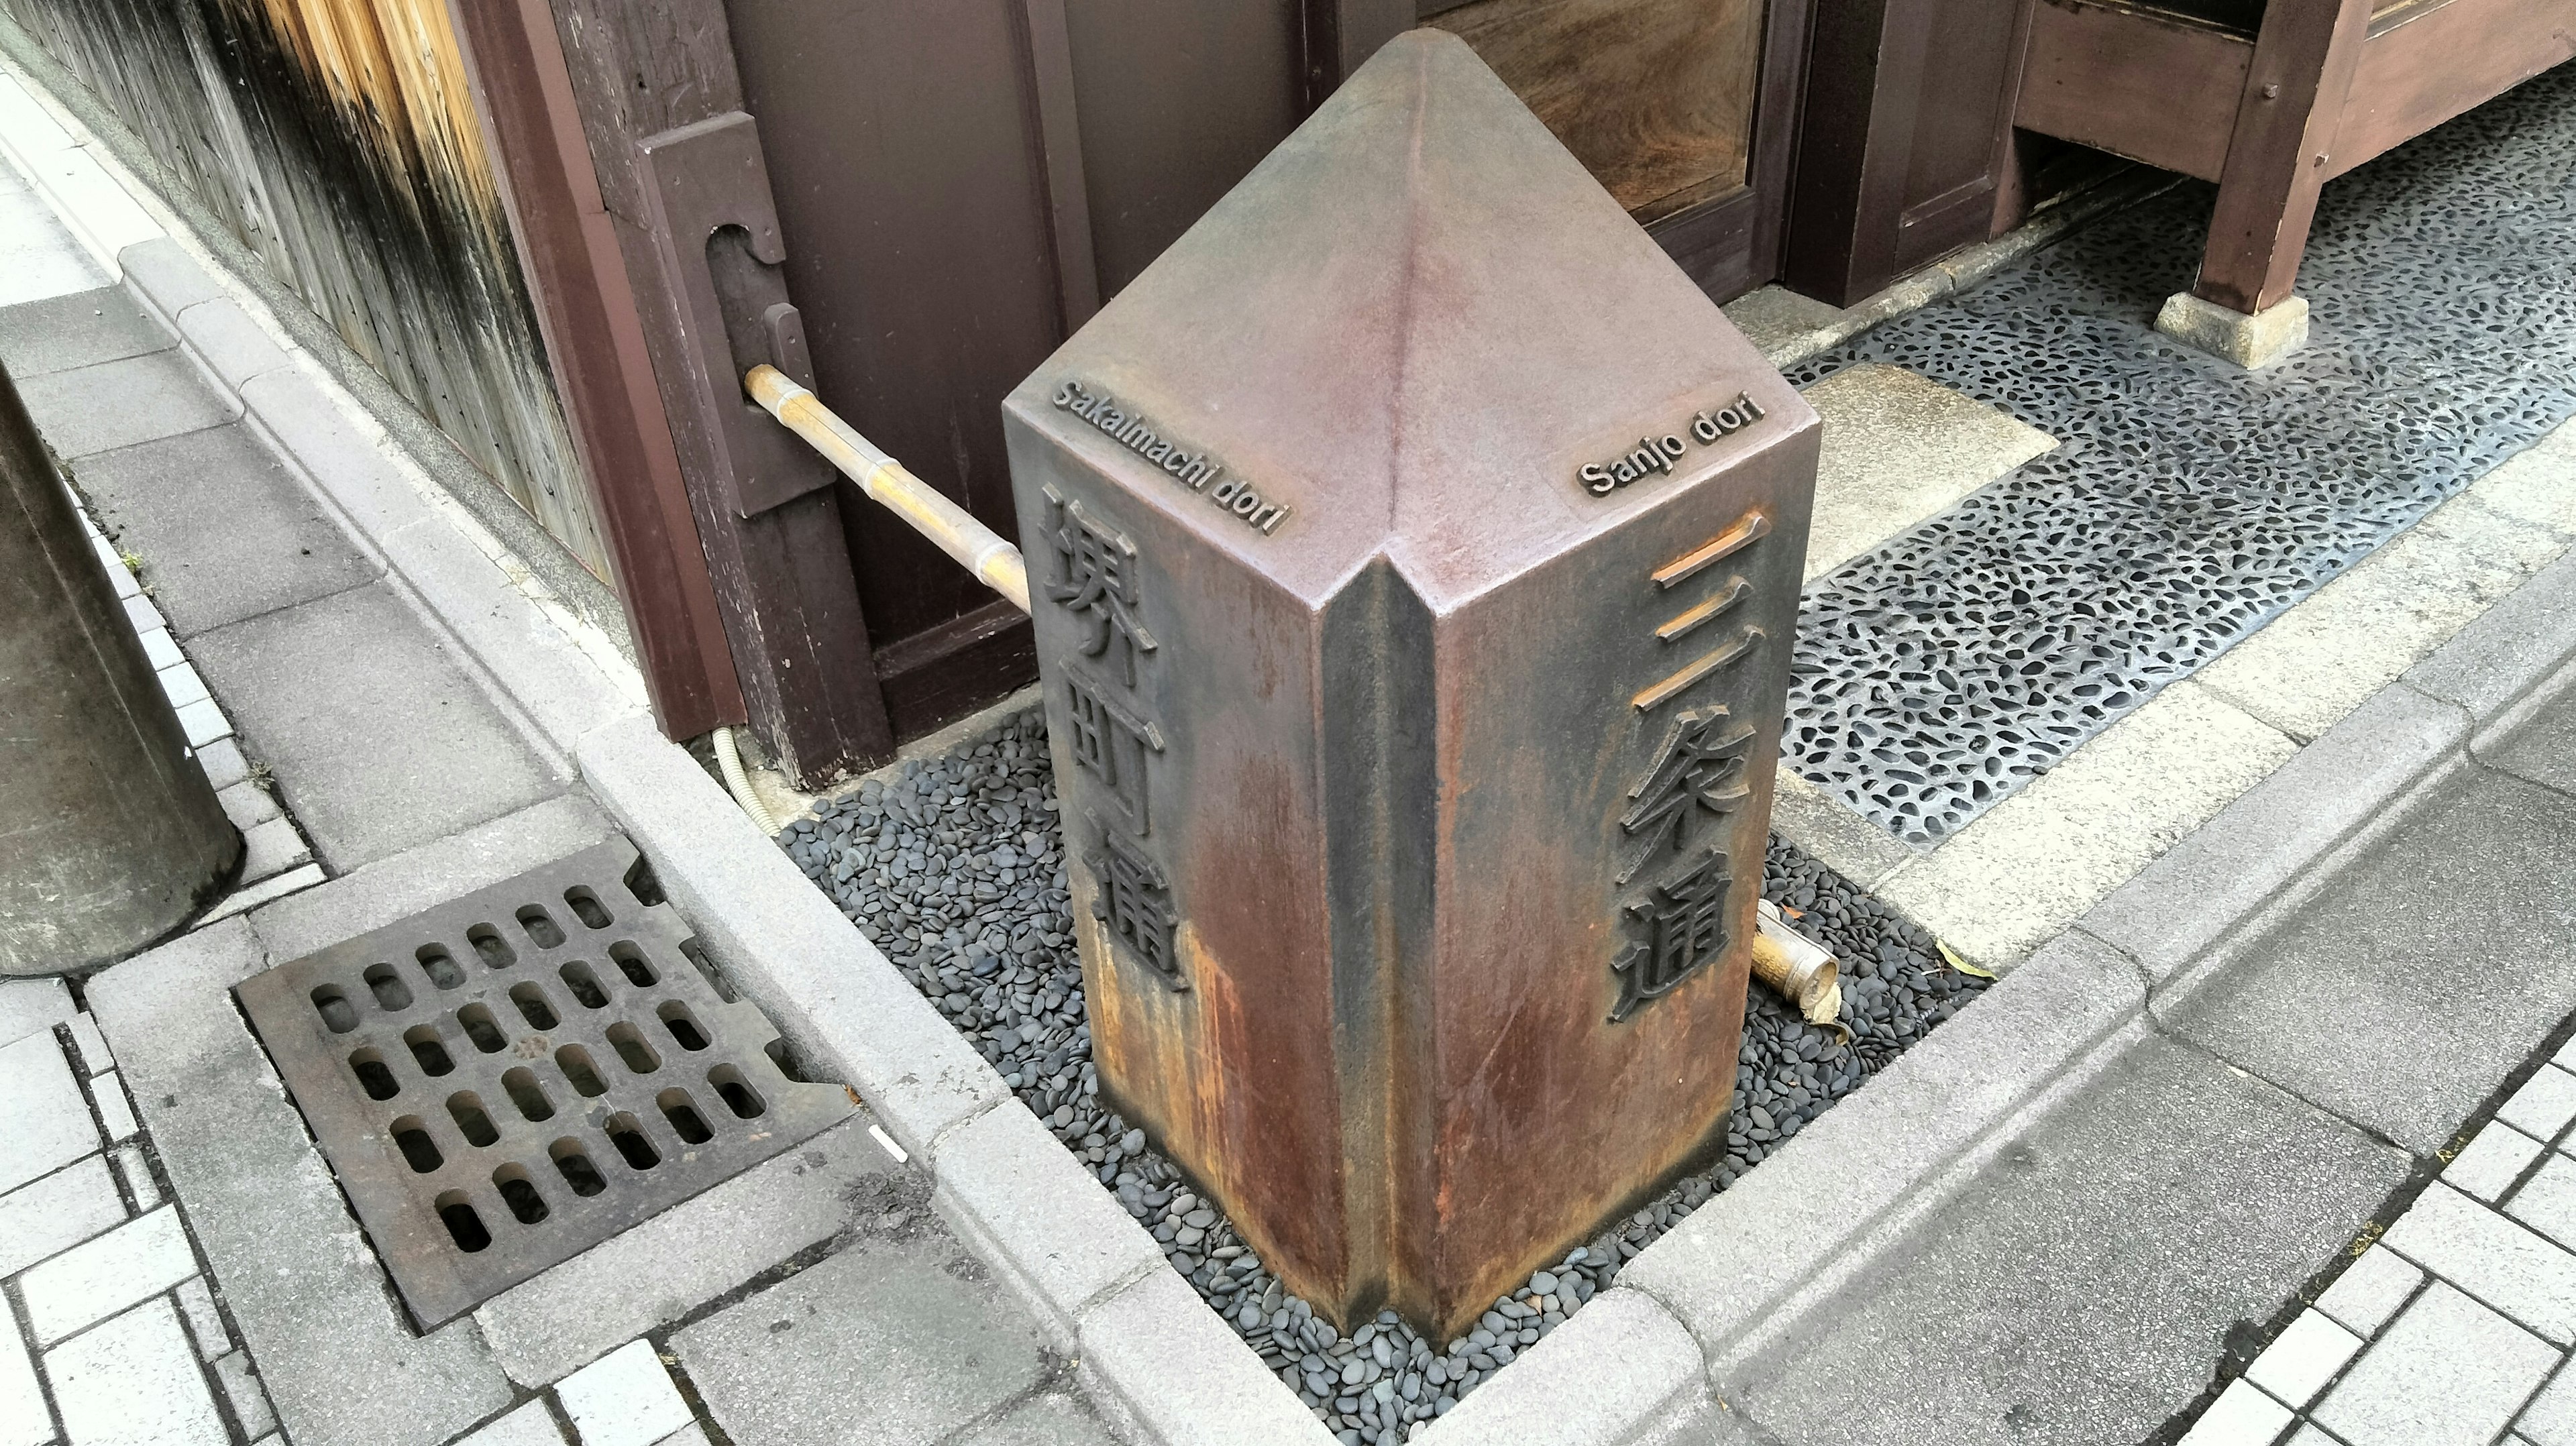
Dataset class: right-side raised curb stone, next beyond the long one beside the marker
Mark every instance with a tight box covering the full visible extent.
[2076,683,2468,987]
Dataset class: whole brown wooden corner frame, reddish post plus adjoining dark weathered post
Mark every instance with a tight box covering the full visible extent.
[448,0,894,789]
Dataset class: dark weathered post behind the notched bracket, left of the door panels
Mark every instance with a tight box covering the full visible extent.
[525,0,894,786]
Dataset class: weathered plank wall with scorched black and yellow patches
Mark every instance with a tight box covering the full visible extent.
[0,0,610,577]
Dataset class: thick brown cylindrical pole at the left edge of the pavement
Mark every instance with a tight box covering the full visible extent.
[0,361,242,975]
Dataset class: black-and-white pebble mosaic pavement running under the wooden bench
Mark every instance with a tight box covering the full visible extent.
[1782,67,2576,846]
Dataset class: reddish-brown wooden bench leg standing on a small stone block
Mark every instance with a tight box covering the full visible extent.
[2192,0,2370,317]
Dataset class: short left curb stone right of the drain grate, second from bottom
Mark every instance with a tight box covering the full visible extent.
[930,1098,1169,1351]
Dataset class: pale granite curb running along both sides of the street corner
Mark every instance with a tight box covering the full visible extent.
[25,39,2576,1446]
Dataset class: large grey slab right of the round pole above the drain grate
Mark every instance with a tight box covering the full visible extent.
[191,583,564,871]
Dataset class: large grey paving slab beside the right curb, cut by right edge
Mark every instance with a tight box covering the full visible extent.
[2169,771,2576,1155]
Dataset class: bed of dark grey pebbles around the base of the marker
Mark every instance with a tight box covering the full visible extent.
[778,709,1986,1446]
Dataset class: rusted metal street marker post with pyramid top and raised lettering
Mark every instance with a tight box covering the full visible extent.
[1007,31,1819,1338]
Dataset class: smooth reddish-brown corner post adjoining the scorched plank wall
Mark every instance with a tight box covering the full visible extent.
[448,0,747,737]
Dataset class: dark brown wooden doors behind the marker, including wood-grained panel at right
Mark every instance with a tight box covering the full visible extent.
[706,0,1809,737]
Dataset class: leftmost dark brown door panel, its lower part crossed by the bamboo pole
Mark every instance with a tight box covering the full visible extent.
[729,0,1059,657]
